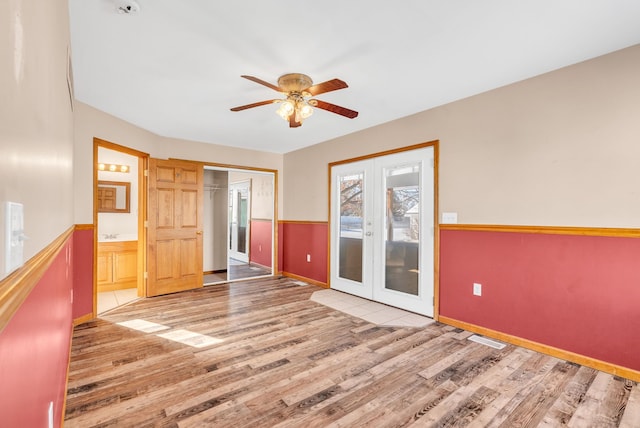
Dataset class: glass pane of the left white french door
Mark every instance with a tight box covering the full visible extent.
[338,173,364,282]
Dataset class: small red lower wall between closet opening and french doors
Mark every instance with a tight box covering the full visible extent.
[278,221,328,284]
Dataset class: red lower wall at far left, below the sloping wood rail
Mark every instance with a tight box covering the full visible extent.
[0,238,75,427]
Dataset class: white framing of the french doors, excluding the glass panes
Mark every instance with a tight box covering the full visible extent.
[329,144,437,317]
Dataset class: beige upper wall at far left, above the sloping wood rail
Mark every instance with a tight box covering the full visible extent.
[0,0,73,278]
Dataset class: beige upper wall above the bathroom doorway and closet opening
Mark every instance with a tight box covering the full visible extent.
[74,102,282,224]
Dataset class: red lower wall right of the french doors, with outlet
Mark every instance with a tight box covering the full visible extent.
[439,230,640,370]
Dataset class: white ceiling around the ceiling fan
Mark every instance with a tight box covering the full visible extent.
[69,0,640,153]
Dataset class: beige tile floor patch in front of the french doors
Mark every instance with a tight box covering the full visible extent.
[311,290,434,327]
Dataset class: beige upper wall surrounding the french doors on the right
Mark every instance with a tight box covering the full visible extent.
[284,45,640,227]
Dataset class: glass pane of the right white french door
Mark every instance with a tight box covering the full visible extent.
[384,163,420,296]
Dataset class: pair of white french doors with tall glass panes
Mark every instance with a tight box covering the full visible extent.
[330,146,435,317]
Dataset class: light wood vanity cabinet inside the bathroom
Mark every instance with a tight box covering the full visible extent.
[97,241,138,292]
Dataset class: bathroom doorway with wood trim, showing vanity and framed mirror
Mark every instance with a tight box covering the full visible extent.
[93,138,148,315]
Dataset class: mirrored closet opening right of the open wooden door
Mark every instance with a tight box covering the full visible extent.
[202,166,276,285]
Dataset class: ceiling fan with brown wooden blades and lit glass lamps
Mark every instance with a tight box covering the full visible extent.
[231,73,358,128]
